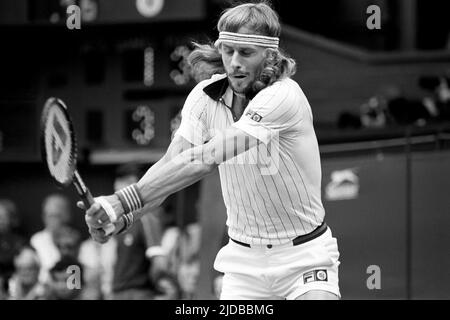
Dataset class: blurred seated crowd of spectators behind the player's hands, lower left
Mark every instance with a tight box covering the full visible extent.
[0,165,204,300]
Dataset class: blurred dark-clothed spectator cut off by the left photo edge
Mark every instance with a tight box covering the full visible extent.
[0,199,25,299]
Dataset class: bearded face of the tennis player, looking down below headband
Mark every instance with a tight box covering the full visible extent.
[221,27,266,94]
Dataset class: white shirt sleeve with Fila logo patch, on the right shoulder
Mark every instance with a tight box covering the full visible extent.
[233,81,307,144]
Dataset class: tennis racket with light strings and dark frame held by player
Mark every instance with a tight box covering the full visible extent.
[41,98,115,235]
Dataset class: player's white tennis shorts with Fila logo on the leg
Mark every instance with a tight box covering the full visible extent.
[214,228,341,300]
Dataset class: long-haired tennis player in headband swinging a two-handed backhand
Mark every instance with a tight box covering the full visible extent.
[80,3,340,299]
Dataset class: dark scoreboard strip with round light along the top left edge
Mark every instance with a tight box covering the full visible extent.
[0,0,207,25]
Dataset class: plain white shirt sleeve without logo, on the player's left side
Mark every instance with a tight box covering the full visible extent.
[175,83,209,145]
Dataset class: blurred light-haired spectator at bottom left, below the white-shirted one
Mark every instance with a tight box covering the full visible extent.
[8,246,45,300]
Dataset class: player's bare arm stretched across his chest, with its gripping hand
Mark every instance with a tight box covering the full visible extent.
[86,126,259,234]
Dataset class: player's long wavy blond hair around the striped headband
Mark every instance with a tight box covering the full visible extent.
[188,2,296,94]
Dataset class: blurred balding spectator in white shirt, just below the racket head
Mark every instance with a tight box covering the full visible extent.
[31,194,70,282]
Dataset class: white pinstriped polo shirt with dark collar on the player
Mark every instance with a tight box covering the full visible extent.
[176,75,325,245]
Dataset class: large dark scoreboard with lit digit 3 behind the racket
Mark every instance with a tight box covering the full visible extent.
[0,0,210,163]
